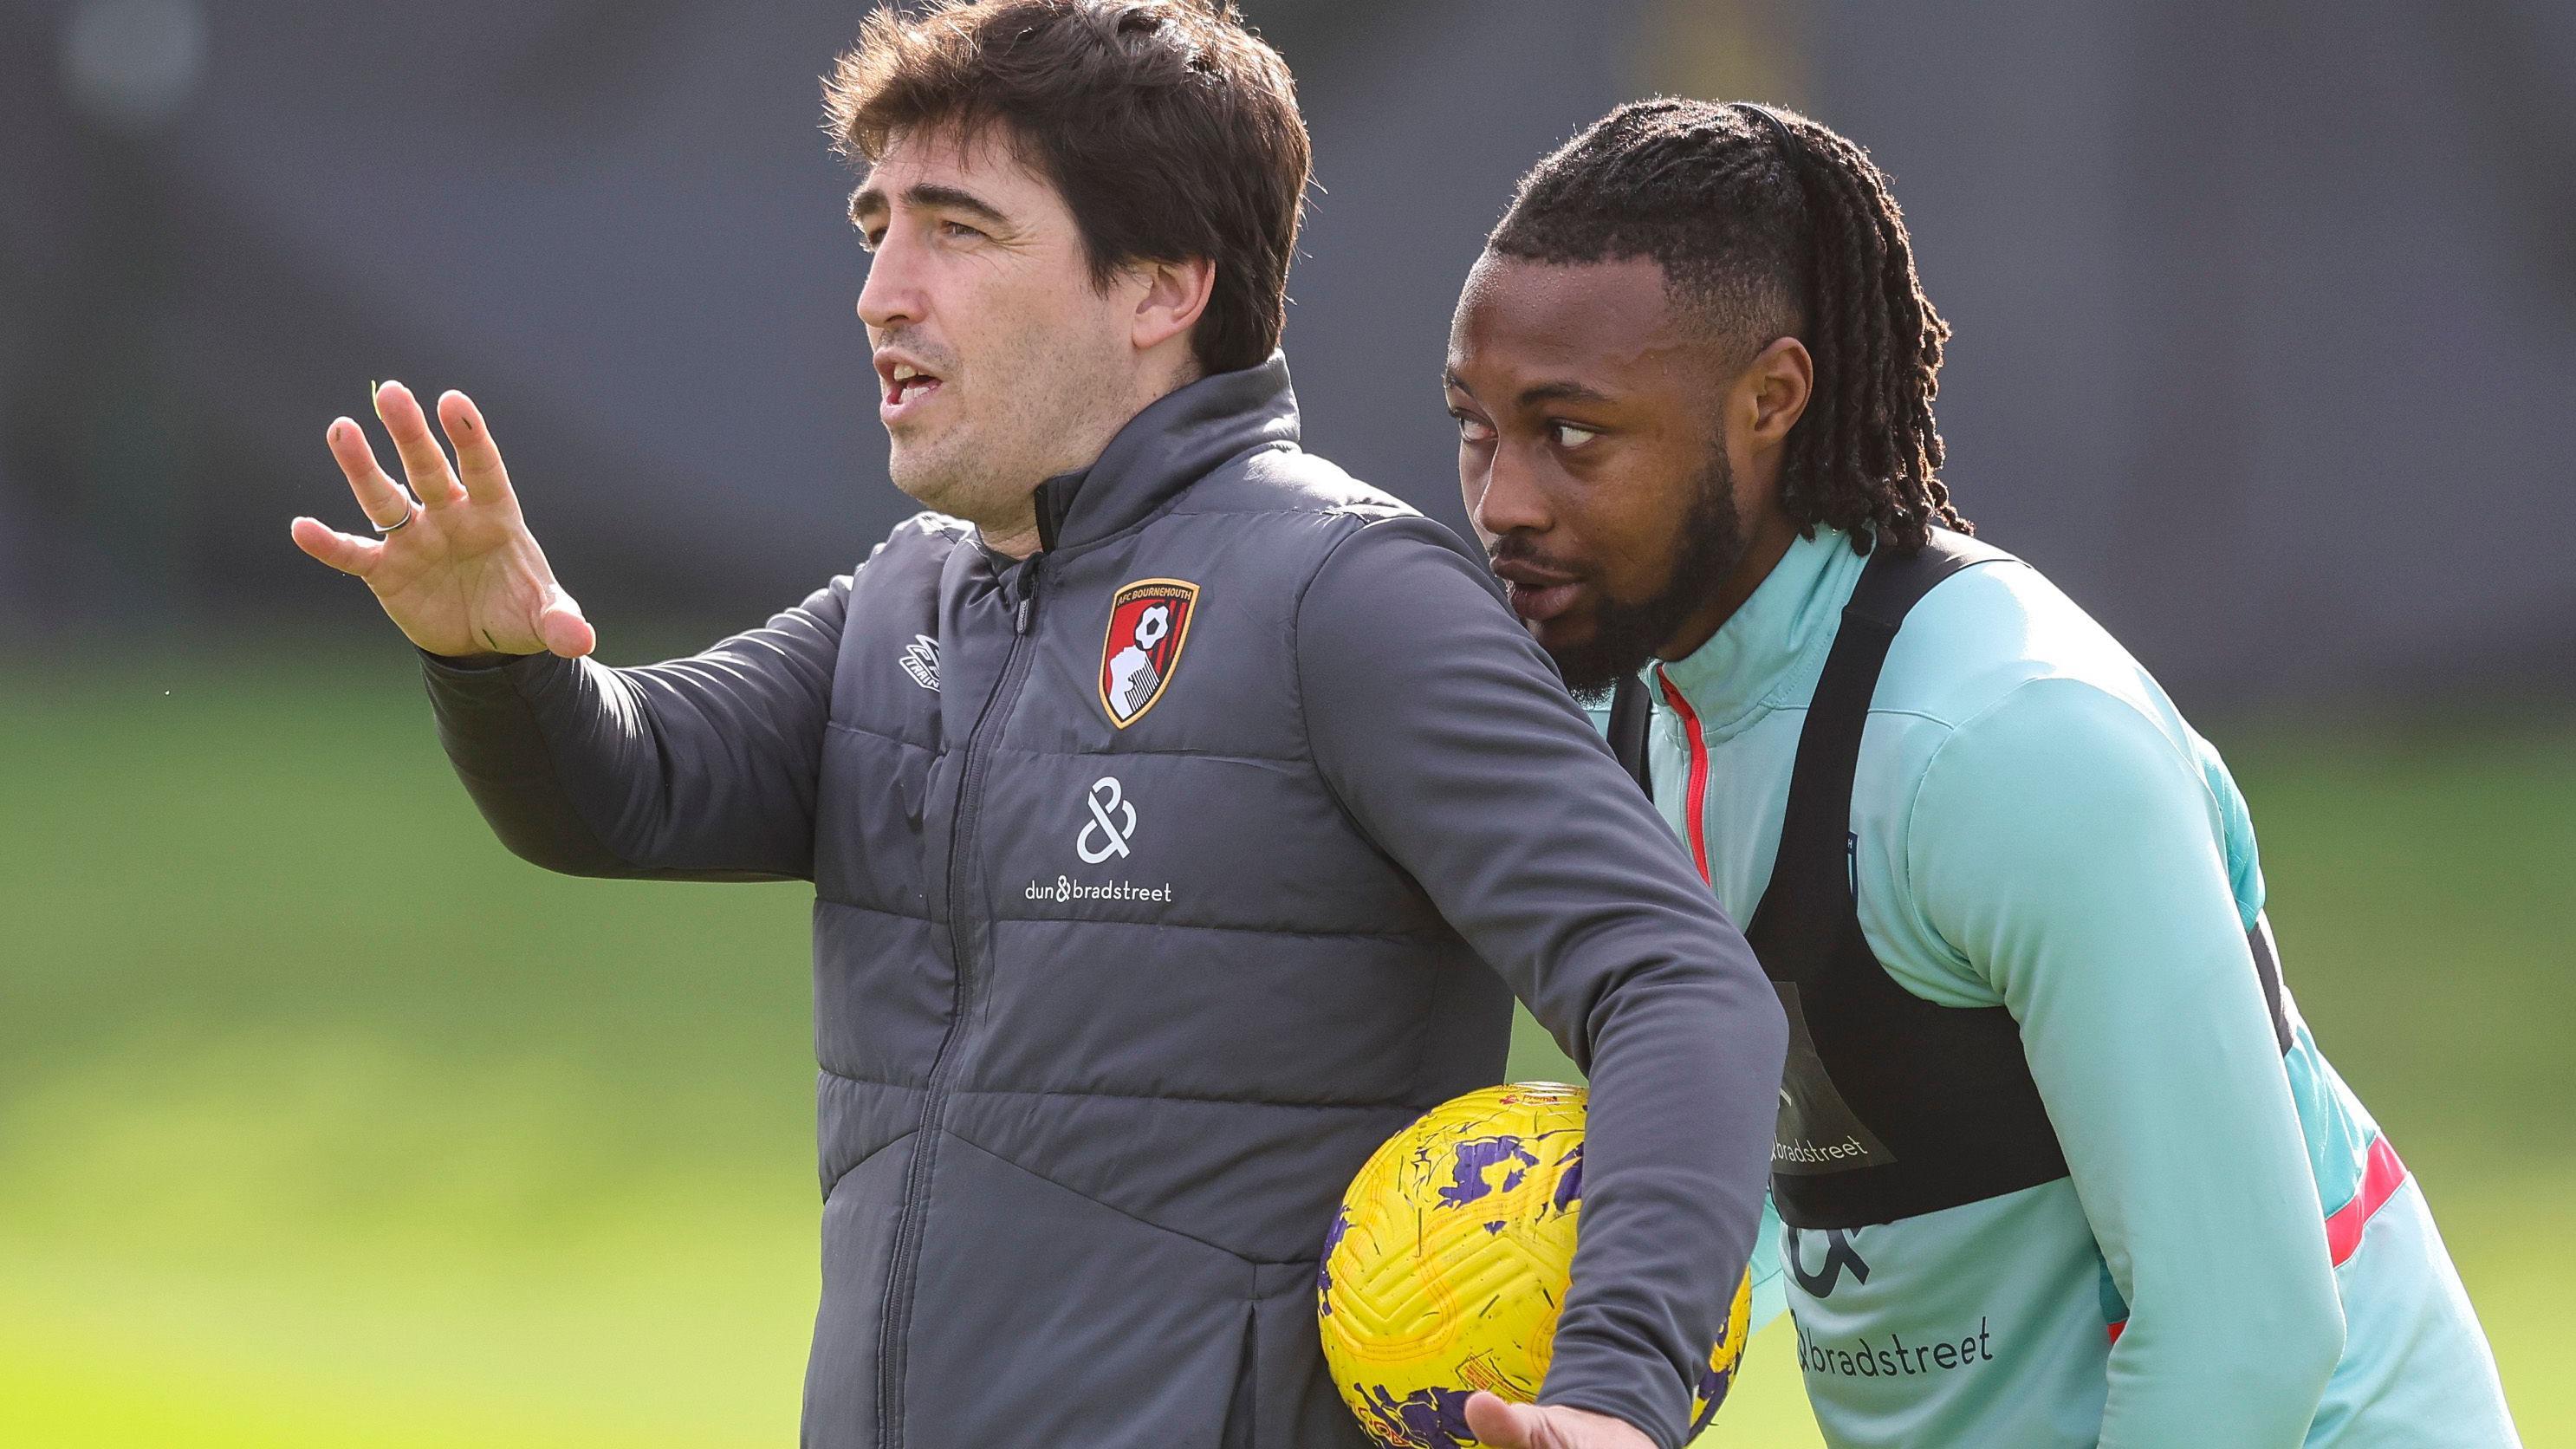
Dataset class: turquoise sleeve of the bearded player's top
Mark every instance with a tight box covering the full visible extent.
[1904,678,2344,1449]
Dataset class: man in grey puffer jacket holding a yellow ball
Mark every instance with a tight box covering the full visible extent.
[294,0,1785,1449]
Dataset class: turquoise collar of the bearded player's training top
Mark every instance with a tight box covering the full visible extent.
[1646,529,1867,737]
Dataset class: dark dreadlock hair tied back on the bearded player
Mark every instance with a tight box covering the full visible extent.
[1486,98,1970,555]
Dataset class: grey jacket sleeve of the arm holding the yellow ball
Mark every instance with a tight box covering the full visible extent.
[1298,518,1788,1449]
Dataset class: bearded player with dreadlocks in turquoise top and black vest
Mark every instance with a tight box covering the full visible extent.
[1448,101,2514,1446]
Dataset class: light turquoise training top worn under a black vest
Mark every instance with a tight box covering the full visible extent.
[1646,531,2517,1449]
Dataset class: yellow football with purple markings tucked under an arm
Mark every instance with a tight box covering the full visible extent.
[1316,1083,1752,1449]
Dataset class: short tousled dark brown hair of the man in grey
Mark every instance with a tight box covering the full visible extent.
[824,0,1311,374]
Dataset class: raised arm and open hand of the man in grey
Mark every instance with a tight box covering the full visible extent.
[294,381,847,880]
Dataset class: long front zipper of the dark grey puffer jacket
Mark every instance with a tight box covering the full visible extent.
[876,555,1046,1449]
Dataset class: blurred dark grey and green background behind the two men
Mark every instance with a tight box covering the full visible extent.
[0,0,2576,1449]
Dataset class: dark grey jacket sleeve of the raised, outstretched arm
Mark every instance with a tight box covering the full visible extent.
[423,577,850,880]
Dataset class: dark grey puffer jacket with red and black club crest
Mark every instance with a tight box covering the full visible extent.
[428,359,1782,1449]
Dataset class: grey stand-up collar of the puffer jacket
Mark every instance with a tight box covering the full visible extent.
[1035,354,1298,552]
